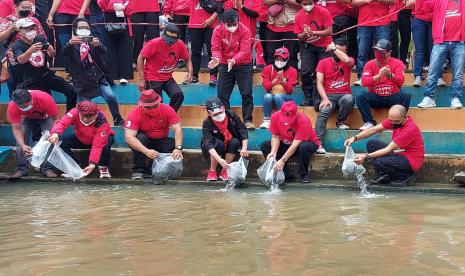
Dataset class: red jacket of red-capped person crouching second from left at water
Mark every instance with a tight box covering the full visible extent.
[50,108,115,165]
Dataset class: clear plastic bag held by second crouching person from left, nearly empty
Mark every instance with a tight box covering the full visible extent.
[47,141,86,180]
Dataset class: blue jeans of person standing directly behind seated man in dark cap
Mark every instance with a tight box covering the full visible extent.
[357,25,391,79]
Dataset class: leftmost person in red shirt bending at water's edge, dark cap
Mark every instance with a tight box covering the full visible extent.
[8,89,58,179]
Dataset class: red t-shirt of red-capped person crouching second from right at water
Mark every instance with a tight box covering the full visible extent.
[270,111,320,146]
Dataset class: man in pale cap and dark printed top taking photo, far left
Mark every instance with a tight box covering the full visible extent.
[12,18,76,111]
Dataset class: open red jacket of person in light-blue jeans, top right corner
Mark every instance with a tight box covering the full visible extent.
[424,0,465,44]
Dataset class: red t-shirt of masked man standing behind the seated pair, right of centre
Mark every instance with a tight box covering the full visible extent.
[294,5,333,48]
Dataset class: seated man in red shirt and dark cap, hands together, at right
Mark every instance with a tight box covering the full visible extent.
[357,39,412,130]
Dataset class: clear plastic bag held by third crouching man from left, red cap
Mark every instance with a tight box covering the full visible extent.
[152,153,182,184]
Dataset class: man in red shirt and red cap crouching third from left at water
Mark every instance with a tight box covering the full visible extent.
[125,89,183,180]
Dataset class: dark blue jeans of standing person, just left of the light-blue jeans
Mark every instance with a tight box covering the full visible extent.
[412,18,433,77]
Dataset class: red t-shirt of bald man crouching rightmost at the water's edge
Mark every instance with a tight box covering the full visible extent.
[381,116,425,172]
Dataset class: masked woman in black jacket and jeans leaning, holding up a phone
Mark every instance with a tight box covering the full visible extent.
[63,18,124,126]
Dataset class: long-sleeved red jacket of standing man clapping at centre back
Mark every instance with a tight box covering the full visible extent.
[211,22,252,65]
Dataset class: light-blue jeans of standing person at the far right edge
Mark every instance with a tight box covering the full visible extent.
[424,42,465,98]
